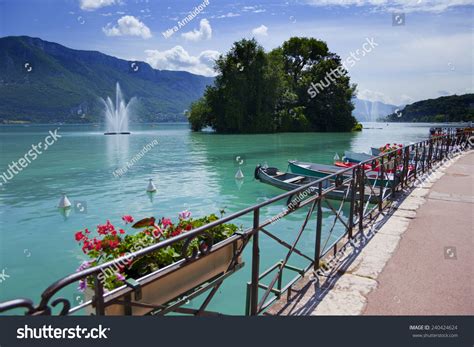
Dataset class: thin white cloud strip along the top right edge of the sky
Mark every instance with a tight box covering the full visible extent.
[307,0,472,13]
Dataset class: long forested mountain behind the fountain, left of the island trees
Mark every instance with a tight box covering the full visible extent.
[0,36,213,123]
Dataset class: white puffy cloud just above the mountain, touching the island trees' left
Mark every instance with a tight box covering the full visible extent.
[145,46,220,76]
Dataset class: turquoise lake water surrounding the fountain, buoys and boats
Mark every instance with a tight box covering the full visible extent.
[0,123,442,314]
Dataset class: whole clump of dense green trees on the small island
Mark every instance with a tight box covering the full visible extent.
[187,37,358,134]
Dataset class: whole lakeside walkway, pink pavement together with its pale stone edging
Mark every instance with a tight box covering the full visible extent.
[267,151,474,315]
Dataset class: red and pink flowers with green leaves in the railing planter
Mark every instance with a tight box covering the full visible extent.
[75,211,243,290]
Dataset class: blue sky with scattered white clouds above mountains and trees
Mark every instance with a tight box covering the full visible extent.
[0,0,474,104]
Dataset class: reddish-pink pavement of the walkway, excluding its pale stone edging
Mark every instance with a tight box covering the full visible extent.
[363,152,474,315]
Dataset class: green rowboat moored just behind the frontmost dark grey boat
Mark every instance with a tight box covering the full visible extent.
[288,160,394,186]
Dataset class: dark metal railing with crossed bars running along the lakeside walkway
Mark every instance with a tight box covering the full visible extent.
[0,131,470,315]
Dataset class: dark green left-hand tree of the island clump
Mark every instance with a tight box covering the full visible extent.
[189,40,278,133]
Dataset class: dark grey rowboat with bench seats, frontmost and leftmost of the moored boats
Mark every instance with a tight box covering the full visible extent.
[255,165,377,203]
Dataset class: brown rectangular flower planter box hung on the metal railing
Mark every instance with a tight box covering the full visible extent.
[85,238,242,316]
